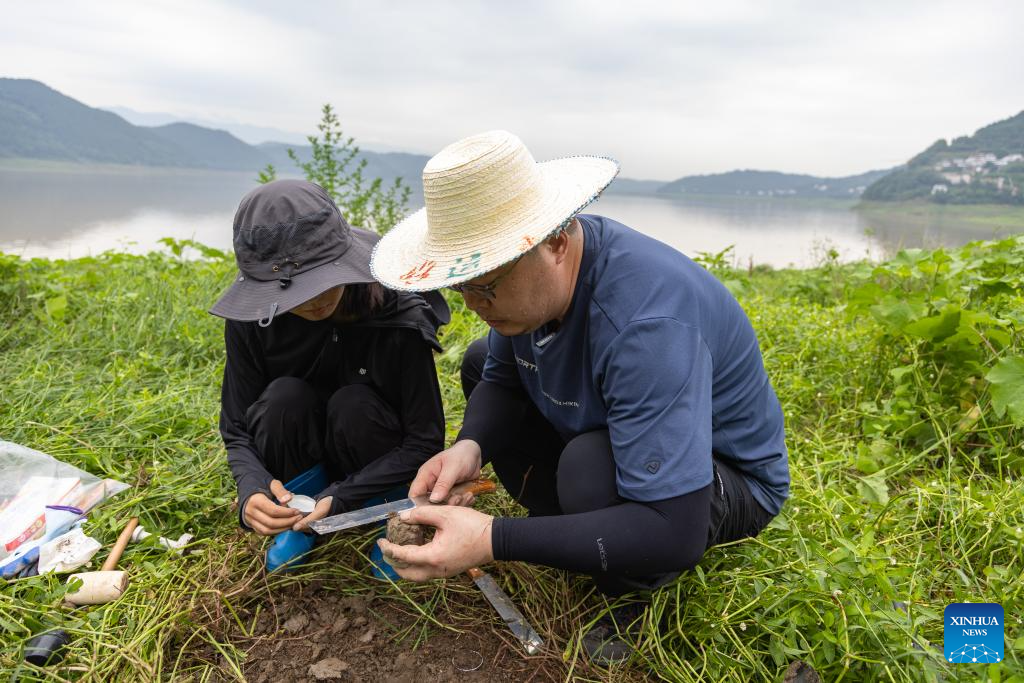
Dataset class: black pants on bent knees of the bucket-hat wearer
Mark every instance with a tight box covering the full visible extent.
[246,377,401,483]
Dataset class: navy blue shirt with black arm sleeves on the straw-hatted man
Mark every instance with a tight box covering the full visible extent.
[460,215,790,572]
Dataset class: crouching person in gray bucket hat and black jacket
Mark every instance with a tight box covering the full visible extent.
[210,180,450,570]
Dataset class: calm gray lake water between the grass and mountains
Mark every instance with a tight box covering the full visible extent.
[0,167,1024,267]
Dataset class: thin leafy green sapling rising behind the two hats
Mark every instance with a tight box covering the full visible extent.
[256,104,412,234]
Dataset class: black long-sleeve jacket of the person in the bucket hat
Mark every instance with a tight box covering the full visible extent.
[220,290,450,520]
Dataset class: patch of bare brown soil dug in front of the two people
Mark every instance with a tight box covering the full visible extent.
[232,586,558,683]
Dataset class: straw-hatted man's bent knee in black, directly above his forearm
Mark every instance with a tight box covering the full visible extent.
[558,430,624,514]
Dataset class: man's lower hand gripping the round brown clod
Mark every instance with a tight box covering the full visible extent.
[377,505,495,581]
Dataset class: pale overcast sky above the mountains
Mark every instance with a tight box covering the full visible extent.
[0,0,1024,179]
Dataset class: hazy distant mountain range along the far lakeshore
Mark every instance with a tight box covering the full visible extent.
[6,78,1024,201]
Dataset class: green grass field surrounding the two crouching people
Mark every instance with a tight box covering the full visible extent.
[0,236,1024,681]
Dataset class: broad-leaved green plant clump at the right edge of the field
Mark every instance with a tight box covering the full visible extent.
[849,237,1024,468]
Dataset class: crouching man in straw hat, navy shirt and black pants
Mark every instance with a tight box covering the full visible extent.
[371,131,790,663]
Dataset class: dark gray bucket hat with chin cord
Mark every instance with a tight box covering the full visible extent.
[210,180,380,327]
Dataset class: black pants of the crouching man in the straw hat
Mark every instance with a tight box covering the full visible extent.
[462,339,772,595]
